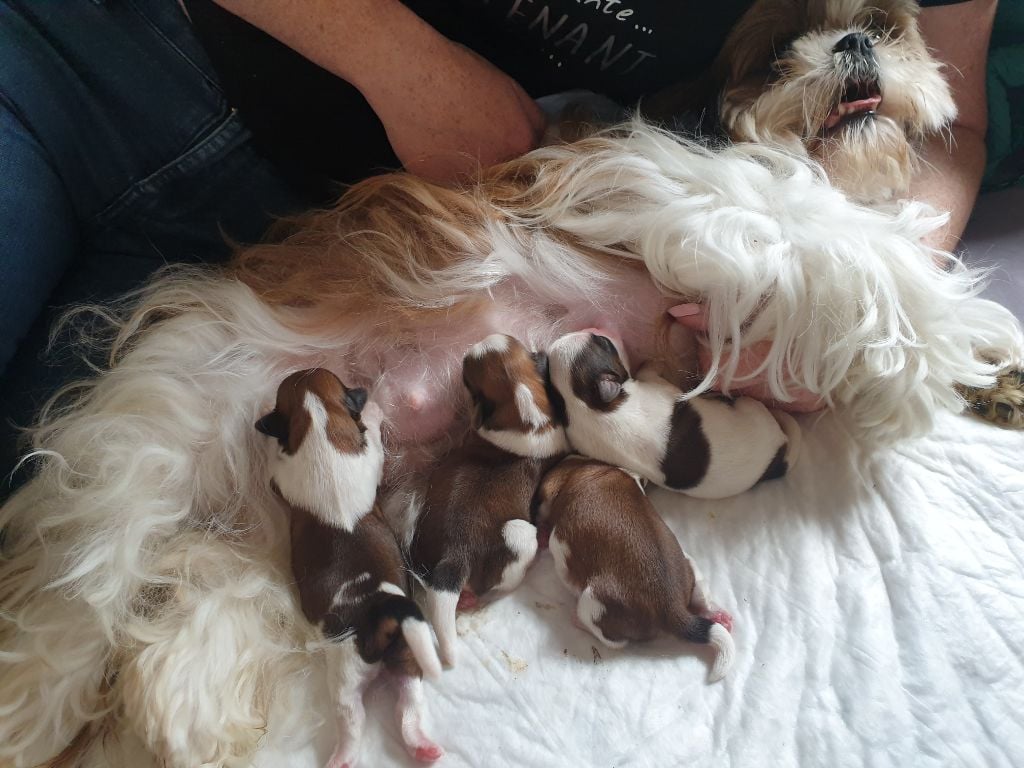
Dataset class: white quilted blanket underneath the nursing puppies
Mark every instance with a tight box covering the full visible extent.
[258,416,1024,768]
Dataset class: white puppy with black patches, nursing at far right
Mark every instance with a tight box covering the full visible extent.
[548,331,800,499]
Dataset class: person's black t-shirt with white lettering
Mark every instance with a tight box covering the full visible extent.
[185,0,963,199]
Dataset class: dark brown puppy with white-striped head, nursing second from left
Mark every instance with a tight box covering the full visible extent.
[410,334,568,665]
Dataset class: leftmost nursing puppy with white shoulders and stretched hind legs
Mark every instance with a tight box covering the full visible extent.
[256,369,442,768]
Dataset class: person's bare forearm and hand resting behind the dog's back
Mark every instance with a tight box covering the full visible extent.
[206,0,544,181]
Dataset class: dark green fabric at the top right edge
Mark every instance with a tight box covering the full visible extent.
[982,0,1024,189]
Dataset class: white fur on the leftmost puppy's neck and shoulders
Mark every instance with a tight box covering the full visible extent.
[270,392,384,531]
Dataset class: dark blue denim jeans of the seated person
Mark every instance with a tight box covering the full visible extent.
[0,0,308,498]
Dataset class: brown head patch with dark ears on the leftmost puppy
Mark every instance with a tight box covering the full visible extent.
[256,368,367,456]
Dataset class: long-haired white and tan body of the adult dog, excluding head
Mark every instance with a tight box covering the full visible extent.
[0,0,1021,766]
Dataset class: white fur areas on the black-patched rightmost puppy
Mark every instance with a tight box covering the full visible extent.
[548,332,796,499]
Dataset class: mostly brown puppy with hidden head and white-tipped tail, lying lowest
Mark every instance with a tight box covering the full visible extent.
[538,456,735,682]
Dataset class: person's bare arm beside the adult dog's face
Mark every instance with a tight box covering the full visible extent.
[910,0,996,251]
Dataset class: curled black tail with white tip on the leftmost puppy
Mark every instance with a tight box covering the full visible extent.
[355,594,441,680]
